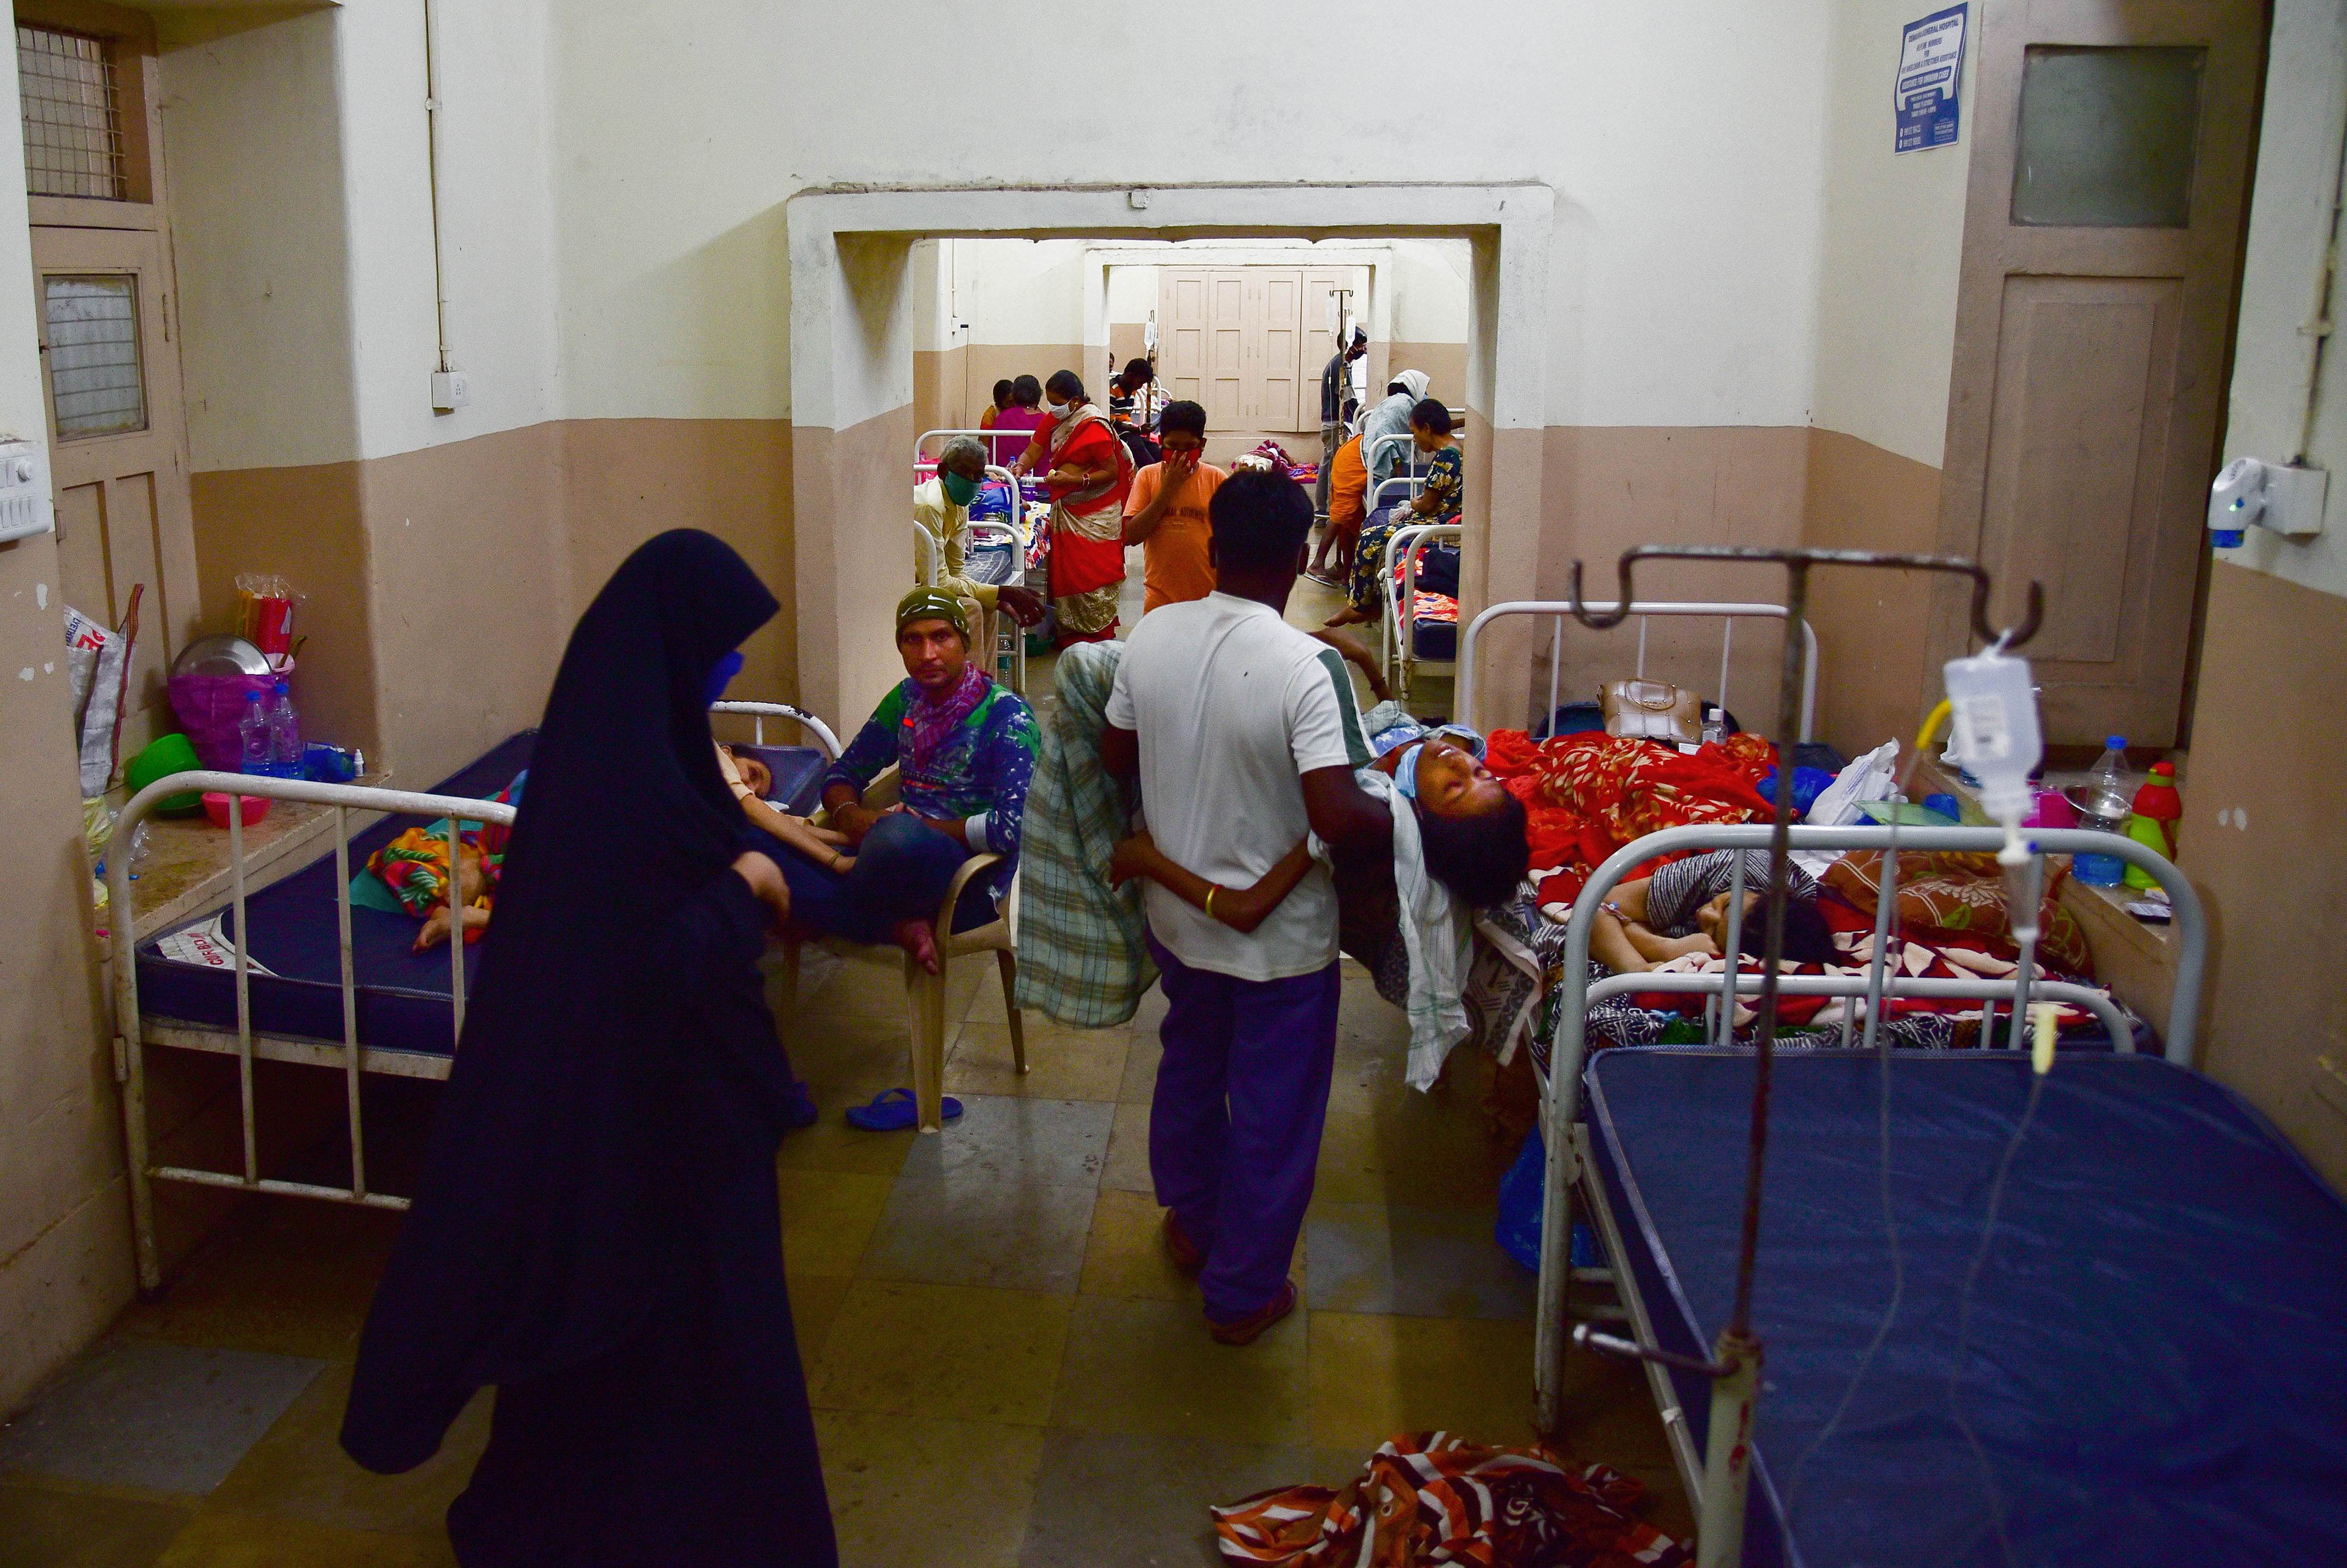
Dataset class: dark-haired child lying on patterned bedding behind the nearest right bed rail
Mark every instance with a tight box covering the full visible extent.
[1589,850,1838,974]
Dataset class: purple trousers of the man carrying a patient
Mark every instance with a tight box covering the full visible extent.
[1150,937,1338,1322]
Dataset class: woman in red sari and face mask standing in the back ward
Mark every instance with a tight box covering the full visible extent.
[1012,371,1133,648]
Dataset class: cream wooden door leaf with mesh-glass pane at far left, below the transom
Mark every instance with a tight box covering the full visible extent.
[33,225,199,758]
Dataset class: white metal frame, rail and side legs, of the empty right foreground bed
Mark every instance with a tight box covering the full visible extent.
[1530,821,2209,1561]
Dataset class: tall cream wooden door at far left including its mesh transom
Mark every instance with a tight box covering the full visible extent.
[17,5,199,758]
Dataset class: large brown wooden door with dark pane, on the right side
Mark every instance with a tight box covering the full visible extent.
[1915,0,2262,747]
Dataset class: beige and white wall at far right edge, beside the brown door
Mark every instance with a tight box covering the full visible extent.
[2180,0,2347,1188]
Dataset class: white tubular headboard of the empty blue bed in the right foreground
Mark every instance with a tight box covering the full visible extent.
[1535,824,2209,1446]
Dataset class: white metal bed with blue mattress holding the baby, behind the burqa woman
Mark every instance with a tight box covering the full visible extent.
[106,702,840,1291]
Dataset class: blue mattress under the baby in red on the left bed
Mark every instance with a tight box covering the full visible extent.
[138,730,824,1056]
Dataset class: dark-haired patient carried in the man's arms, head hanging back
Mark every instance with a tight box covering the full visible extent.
[1108,704,1532,1007]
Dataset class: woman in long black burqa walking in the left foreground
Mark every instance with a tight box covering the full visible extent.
[343,530,838,1568]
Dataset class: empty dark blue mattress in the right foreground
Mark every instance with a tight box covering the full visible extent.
[1587,1049,2347,1568]
